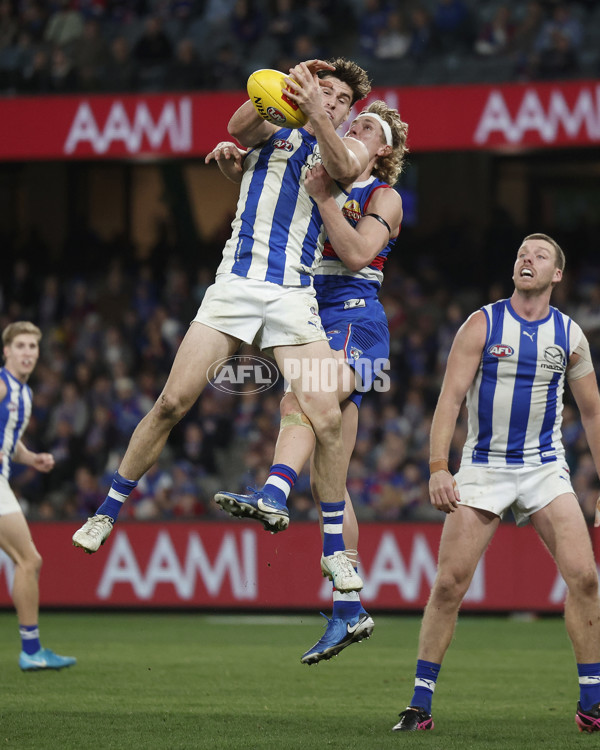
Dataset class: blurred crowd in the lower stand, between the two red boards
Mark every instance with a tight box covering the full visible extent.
[0,217,600,521]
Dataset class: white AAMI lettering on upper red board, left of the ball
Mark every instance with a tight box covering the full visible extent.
[64,97,192,154]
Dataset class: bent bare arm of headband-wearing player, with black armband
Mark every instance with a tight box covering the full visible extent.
[304,165,402,271]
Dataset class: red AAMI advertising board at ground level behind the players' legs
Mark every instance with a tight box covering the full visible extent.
[0,521,598,612]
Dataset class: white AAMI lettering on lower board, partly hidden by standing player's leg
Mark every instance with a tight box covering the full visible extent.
[319,533,485,605]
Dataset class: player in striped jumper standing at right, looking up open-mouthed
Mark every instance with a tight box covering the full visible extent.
[394,234,600,732]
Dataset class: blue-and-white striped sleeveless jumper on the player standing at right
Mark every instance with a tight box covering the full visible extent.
[462,300,583,467]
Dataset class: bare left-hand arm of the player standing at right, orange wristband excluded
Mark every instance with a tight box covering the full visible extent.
[429,311,487,513]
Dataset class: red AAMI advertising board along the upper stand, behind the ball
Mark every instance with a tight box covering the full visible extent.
[0,81,600,160]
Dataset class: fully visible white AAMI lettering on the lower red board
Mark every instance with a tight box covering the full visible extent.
[97,531,257,600]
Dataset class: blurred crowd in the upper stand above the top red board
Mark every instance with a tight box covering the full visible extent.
[0,0,600,95]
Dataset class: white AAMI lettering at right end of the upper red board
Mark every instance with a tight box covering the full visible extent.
[474,86,600,144]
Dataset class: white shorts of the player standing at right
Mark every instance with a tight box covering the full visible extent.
[454,461,575,526]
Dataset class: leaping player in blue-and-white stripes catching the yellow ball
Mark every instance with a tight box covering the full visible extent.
[73,59,370,591]
